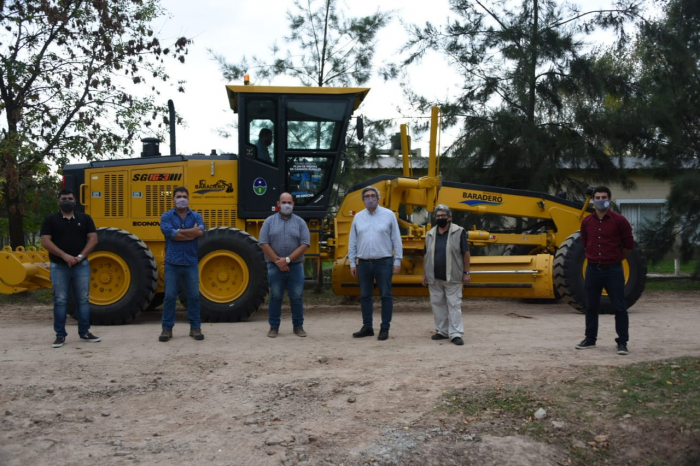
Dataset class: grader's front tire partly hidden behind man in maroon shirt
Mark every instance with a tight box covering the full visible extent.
[553,231,647,314]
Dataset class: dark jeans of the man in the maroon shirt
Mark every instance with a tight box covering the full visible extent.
[586,264,629,343]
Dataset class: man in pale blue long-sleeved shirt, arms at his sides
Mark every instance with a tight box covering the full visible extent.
[348,186,403,340]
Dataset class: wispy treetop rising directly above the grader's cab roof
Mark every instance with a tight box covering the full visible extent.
[209,0,394,87]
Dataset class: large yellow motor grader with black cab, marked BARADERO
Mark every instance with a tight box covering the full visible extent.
[0,86,646,325]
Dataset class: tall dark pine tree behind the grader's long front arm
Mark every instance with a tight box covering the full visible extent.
[404,0,638,195]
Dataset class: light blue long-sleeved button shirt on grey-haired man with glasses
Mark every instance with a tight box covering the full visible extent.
[348,206,403,267]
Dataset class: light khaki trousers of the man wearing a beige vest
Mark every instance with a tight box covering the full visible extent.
[428,279,464,340]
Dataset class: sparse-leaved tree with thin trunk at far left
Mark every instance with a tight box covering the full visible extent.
[0,0,190,246]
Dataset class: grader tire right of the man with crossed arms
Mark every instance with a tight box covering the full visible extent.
[199,227,268,322]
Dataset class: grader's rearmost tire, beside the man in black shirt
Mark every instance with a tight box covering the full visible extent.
[71,228,158,325]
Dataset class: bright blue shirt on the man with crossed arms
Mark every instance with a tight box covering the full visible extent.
[160,208,204,265]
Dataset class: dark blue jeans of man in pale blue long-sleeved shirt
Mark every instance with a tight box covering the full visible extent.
[357,257,394,330]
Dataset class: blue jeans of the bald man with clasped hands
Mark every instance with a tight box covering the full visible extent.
[267,262,304,328]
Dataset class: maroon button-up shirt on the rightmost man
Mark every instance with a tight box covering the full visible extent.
[581,210,634,264]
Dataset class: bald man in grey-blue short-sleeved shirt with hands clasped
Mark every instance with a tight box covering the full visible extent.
[259,193,311,338]
